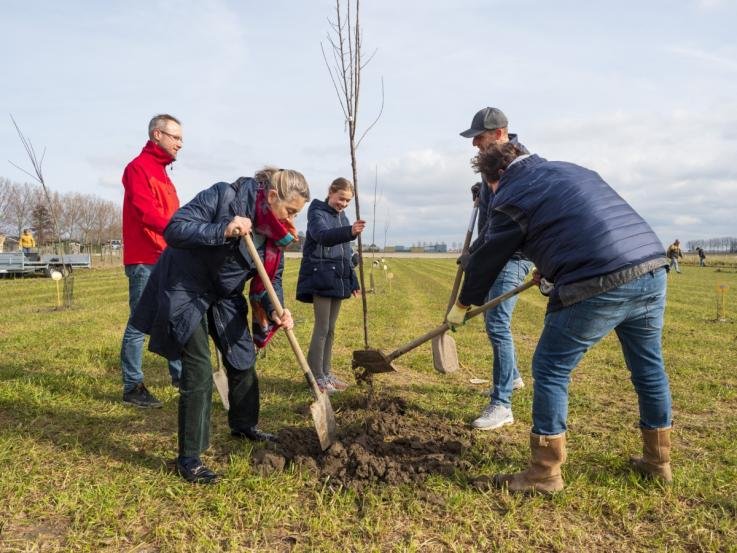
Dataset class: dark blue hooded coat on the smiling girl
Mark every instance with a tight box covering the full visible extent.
[297,200,360,303]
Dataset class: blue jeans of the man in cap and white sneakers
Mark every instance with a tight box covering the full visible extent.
[484,259,532,407]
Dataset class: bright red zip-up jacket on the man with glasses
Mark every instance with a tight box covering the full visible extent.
[123,140,179,265]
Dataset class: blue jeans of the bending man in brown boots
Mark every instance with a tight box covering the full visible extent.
[532,268,671,435]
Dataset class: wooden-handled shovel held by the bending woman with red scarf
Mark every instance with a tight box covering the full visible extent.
[243,234,336,451]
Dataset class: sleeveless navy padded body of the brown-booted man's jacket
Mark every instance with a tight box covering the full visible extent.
[492,155,664,286]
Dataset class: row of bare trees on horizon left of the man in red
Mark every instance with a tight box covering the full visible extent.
[0,177,122,245]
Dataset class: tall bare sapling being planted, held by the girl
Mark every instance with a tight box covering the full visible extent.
[320,0,384,348]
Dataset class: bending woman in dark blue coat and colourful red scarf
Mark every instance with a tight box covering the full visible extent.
[133,167,310,484]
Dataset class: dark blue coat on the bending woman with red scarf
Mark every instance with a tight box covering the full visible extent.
[132,177,284,370]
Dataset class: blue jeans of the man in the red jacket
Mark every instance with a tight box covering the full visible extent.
[120,264,182,392]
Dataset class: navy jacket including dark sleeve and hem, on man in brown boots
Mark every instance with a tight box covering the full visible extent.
[459,155,667,310]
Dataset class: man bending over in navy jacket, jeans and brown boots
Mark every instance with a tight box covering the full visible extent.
[447,143,672,492]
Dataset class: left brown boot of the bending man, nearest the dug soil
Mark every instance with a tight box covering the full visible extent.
[494,432,566,493]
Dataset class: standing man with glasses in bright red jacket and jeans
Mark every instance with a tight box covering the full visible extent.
[120,114,182,407]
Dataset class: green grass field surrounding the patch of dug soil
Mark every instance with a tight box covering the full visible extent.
[0,259,737,552]
